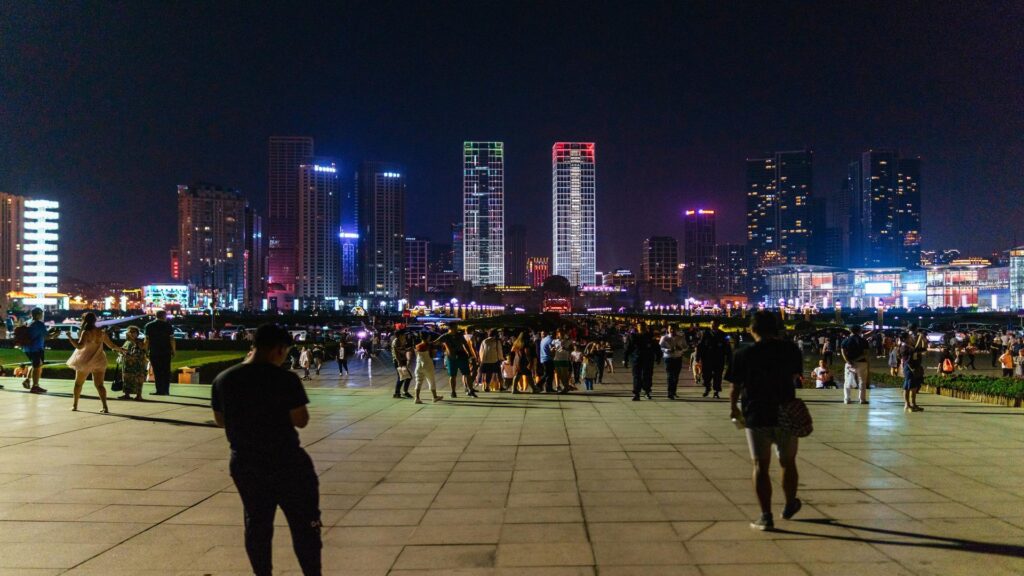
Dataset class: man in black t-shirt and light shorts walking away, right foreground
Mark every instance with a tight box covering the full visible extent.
[727,311,804,530]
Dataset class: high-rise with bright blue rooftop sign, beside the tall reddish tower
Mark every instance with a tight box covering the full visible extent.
[295,159,341,308]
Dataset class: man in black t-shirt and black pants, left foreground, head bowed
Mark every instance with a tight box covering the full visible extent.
[210,324,322,576]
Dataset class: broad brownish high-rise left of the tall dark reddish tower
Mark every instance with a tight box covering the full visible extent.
[178,183,247,308]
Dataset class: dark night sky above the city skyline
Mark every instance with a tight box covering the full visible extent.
[0,1,1024,283]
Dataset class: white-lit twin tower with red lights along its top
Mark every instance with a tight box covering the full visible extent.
[551,142,597,286]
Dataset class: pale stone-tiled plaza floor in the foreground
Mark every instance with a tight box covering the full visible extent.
[0,356,1024,576]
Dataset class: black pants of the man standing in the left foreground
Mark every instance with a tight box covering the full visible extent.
[230,450,322,576]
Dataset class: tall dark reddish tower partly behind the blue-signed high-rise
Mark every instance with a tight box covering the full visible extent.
[266,136,313,310]
